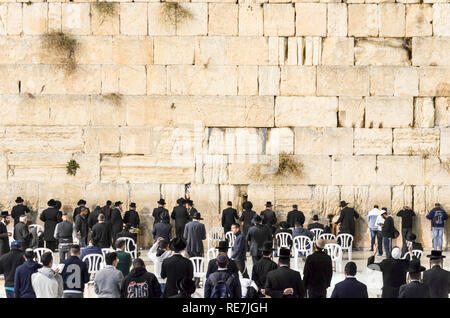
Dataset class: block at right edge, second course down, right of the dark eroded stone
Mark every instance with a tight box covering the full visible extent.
[412,37,450,66]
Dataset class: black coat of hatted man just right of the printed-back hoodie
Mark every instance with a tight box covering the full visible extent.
[161,254,194,298]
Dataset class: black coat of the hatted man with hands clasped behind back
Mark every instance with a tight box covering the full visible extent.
[265,266,305,298]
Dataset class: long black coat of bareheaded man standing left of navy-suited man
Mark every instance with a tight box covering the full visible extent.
[303,251,333,292]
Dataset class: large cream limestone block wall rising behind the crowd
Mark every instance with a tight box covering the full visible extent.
[0,0,450,248]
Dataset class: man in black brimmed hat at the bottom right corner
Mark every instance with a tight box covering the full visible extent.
[423,250,450,298]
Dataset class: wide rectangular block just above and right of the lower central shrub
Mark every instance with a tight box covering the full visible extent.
[294,127,353,155]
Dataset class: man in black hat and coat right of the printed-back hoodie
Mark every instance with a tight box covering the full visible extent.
[161,236,194,298]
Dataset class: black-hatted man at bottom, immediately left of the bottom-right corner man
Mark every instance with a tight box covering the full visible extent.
[398,259,430,298]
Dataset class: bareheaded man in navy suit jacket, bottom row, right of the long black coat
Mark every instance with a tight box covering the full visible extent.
[331,262,369,298]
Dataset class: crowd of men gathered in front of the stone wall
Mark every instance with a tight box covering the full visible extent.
[0,197,450,298]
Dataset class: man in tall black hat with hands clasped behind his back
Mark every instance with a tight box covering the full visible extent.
[264,248,305,298]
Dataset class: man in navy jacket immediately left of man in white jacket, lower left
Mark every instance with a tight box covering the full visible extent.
[14,248,42,298]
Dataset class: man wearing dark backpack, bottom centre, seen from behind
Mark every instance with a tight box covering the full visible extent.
[205,254,242,298]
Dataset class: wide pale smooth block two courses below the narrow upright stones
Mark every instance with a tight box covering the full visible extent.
[275,97,338,127]
